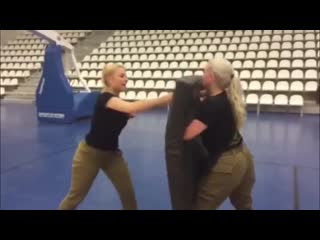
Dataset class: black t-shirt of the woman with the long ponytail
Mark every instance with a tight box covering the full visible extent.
[196,91,242,157]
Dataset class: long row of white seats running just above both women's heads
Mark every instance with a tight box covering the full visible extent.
[83,50,317,62]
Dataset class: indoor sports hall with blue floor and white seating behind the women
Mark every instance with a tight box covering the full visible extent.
[0,30,320,210]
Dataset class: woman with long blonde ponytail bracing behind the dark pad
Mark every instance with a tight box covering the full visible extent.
[184,58,255,210]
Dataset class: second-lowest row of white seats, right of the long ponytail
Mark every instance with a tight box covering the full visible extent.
[241,80,318,92]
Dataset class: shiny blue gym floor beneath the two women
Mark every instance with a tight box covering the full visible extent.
[1,103,319,210]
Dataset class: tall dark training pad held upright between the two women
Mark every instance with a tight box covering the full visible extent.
[165,76,207,210]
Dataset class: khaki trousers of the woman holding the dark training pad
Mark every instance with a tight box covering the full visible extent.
[194,144,255,210]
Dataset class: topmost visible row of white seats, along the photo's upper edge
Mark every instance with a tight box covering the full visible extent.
[113,30,316,37]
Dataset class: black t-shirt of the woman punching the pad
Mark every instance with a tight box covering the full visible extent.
[86,92,129,151]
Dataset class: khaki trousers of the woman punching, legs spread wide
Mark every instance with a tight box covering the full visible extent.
[59,141,137,210]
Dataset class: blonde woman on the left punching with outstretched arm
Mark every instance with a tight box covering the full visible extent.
[59,64,172,210]
